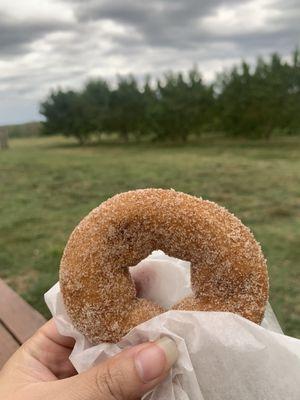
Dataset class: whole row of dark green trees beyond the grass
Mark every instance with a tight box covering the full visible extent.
[40,49,300,144]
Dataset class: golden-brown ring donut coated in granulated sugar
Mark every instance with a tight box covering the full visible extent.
[60,189,269,344]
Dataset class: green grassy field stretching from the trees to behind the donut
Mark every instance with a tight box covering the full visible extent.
[0,137,300,338]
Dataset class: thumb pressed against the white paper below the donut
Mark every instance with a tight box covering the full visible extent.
[56,337,178,400]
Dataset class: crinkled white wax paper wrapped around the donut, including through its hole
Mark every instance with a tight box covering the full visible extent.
[45,251,300,400]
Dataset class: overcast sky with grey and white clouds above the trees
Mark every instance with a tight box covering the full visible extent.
[0,0,300,125]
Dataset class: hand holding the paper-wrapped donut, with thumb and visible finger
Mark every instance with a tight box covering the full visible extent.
[0,320,178,400]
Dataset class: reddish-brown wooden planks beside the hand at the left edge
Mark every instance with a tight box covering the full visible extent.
[0,279,46,369]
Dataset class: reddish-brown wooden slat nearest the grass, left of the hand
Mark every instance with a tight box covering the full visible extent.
[0,279,46,343]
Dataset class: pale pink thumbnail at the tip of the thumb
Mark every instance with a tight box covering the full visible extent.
[135,337,178,383]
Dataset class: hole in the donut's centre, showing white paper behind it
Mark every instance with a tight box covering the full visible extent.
[129,250,192,310]
